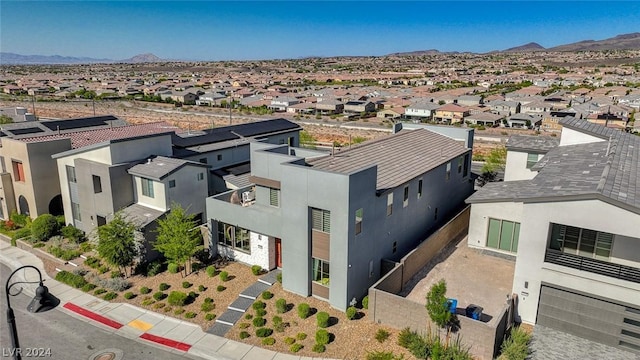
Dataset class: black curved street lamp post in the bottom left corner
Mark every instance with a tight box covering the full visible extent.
[5,265,55,360]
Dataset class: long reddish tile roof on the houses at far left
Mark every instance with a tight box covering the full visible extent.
[18,121,180,149]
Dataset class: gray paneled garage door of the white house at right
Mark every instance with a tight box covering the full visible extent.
[536,285,640,352]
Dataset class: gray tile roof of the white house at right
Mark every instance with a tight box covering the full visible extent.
[467,118,640,213]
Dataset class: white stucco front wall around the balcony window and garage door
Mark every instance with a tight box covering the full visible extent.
[513,200,640,323]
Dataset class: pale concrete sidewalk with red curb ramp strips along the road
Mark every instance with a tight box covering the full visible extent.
[0,241,336,360]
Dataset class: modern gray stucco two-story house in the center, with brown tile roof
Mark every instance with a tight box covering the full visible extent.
[207,128,473,310]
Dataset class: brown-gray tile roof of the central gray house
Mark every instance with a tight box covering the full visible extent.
[308,129,469,191]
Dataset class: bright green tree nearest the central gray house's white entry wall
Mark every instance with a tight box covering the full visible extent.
[153,203,203,275]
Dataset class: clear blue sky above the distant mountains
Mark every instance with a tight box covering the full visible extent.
[0,0,640,60]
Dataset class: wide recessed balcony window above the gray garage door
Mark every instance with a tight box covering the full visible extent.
[549,224,613,261]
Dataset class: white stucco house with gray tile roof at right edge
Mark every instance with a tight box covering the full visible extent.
[467,117,640,352]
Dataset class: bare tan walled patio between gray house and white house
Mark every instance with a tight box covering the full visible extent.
[398,236,515,322]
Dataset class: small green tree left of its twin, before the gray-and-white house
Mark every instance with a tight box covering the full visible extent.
[97,212,139,276]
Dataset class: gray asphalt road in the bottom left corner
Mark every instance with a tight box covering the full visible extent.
[0,264,194,360]
